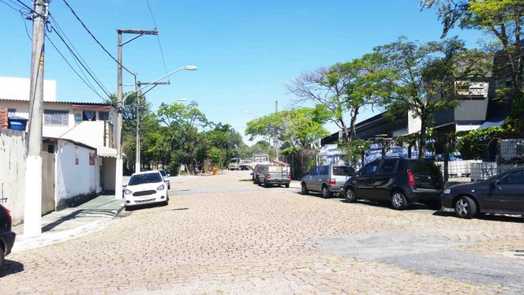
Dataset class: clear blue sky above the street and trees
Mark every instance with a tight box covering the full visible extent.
[0,0,486,141]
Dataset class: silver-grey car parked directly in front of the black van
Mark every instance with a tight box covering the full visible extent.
[301,165,355,198]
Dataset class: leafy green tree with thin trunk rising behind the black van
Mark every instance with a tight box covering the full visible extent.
[375,38,466,158]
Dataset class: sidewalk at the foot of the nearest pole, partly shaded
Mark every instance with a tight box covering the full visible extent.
[13,195,124,252]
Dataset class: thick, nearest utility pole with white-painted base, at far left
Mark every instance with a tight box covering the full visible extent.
[24,0,48,236]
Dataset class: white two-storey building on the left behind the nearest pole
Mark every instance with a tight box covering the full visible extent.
[0,77,116,222]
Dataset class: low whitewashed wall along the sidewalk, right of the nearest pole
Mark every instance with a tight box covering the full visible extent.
[55,140,102,208]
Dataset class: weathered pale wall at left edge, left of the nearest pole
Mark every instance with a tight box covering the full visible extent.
[0,130,26,224]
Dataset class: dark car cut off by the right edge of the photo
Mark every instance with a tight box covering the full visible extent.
[442,168,524,218]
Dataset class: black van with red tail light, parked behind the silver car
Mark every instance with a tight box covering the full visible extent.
[344,158,443,210]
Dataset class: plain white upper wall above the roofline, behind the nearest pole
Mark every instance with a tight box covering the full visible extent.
[0,77,56,101]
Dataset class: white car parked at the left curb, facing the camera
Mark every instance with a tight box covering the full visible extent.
[124,171,169,208]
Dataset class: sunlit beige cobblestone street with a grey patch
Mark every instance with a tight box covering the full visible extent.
[0,172,524,295]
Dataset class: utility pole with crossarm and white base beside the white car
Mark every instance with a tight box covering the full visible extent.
[115,29,158,200]
